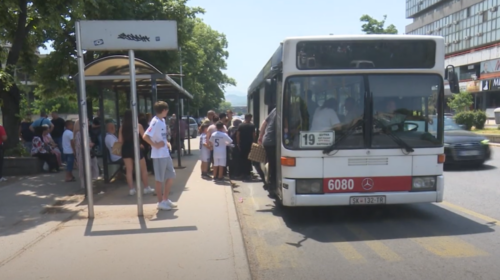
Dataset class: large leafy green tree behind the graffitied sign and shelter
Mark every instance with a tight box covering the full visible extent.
[37,0,236,119]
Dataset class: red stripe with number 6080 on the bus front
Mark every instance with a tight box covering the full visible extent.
[323,176,412,193]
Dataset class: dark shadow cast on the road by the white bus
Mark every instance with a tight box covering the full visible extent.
[260,201,494,242]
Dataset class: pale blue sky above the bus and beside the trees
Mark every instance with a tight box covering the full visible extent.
[41,0,411,99]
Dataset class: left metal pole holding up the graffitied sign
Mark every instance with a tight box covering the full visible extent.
[75,21,94,219]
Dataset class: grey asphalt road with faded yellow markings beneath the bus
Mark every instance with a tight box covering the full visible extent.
[234,148,500,280]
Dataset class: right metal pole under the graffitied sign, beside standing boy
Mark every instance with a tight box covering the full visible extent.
[128,50,146,216]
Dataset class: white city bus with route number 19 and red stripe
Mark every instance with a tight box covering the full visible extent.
[248,35,459,206]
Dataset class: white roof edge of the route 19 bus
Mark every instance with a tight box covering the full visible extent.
[248,34,444,95]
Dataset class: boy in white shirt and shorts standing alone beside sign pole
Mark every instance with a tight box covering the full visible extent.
[142,101,177,210]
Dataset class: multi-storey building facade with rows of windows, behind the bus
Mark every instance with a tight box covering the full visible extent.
[406,0,500,118]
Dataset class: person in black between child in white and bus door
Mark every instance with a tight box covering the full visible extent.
[236,114,255,180]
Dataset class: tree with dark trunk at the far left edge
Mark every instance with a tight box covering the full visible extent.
[0,0,76,148]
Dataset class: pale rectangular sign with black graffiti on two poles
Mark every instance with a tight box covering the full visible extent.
[80,20,178,51]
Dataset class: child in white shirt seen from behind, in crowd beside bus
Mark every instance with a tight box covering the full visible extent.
[210,122,233,181]
